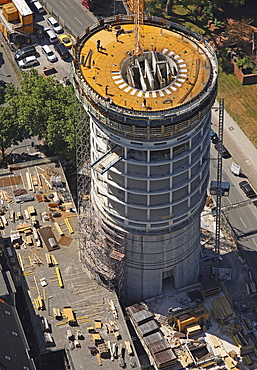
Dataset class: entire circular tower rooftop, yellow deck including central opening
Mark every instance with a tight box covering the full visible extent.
[80,22,213,112]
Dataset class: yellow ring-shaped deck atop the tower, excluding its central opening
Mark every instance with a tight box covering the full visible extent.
[80,24,211,111]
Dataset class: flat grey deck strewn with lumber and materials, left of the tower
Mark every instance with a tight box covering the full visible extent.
[0,151,139,370]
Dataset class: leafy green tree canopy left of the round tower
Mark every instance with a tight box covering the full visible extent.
[0,69,85,162]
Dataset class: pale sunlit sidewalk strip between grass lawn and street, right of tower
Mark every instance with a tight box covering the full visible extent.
[212,101,257,190]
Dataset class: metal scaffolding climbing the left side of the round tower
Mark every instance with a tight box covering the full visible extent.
[76,105,125,300]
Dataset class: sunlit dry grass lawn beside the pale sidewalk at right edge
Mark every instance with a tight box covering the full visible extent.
[218,72,257,147]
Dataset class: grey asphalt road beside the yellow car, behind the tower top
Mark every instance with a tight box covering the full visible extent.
[43,0,98,37]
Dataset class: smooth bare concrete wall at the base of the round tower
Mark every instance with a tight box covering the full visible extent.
[125,217,200,303]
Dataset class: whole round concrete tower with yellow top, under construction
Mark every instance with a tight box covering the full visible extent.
[73,16,217,302]
